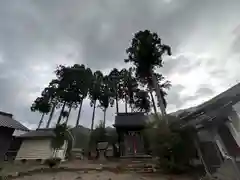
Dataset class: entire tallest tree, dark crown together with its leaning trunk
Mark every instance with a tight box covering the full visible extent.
[125,30,171,115]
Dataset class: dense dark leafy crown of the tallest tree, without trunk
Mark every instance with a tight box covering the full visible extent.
[125,30,171,78]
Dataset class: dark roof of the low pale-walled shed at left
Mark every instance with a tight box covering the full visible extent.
[20,129,54,138]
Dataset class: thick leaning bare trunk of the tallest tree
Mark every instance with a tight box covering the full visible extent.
[152,72,168,123]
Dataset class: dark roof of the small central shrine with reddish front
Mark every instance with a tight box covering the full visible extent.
[114,113,148,127]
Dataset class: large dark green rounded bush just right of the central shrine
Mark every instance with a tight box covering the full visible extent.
[145,114,195,173]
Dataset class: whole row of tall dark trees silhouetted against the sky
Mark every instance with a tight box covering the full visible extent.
[31,30,171,130]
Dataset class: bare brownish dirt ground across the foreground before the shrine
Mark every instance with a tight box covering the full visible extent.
[2,161,198,180]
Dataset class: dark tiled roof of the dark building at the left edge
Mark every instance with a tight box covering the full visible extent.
[0,111,29,131]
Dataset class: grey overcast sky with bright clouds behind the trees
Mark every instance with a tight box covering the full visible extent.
[0,0,240,128]
